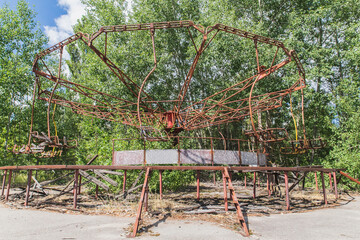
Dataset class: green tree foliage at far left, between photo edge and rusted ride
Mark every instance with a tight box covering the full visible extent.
[0,1,47,164]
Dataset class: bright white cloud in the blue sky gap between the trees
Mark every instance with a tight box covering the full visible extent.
[44,0,85,45]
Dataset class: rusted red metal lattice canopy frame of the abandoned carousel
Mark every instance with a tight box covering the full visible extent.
[33,21,305,139]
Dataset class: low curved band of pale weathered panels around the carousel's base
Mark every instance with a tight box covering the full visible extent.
[113,149,266,166]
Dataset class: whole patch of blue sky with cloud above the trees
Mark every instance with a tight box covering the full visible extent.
[0,0,85,45]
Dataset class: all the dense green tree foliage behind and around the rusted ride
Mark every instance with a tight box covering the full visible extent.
[0,0,360,189]
